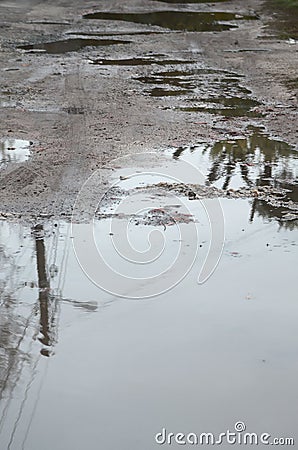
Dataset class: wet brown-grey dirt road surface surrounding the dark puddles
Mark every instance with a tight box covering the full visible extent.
[0,0,297,218]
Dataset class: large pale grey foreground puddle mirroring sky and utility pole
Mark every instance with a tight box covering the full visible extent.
[0,191,298,450]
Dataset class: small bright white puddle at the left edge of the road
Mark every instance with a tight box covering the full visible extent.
[0,139,30,167]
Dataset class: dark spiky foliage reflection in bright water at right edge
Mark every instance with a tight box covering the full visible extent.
[173,127,298,227]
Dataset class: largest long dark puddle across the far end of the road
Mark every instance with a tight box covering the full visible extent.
[83,11,256,31]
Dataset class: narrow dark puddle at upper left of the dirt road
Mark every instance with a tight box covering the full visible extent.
[19,38,130,54]
